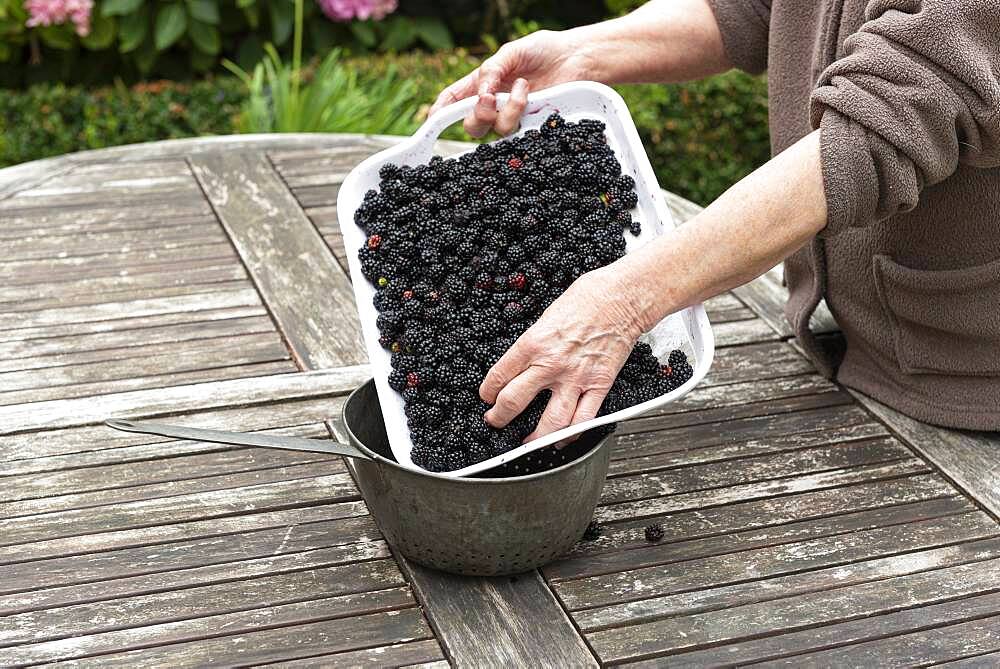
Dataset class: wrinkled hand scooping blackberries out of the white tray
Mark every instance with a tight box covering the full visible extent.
[479,264,644,441]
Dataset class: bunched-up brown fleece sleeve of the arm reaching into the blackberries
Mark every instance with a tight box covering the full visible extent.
[810,0,1000,236]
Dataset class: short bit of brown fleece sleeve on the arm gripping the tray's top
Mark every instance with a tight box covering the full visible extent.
[708,0,771,74]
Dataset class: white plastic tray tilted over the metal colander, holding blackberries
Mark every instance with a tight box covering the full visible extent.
[337,81,715,476]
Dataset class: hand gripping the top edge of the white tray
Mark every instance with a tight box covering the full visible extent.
[428,30,593,137]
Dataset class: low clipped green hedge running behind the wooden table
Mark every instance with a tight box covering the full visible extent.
[0,51,769,204]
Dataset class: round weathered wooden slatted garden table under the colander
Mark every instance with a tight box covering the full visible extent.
[0,135,1000,667]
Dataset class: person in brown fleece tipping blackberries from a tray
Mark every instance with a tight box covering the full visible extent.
[432,0,1000,436]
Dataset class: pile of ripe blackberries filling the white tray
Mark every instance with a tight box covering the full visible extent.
[355,114,692,471]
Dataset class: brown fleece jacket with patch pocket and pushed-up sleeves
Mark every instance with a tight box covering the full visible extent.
[709,0,1000,430]
